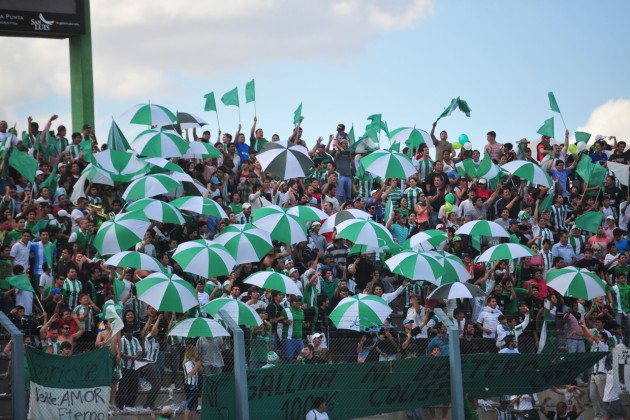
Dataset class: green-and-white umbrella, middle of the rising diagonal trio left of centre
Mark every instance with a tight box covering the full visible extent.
[214,223,273,264]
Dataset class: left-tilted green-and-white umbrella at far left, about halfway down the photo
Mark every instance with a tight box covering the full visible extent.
[94,211,151,255]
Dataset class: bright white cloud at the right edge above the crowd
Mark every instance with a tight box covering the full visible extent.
[576,98,630,142]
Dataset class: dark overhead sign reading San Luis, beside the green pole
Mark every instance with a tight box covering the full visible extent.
[0,0,85,38]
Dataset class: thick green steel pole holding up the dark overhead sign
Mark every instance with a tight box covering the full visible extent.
[69,0,95,132]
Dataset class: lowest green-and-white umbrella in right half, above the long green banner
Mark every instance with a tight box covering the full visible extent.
[329,293,392,331]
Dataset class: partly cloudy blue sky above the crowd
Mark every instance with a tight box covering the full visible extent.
[0,0,630,152]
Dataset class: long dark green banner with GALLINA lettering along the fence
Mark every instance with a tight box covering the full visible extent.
[202,353,603,420]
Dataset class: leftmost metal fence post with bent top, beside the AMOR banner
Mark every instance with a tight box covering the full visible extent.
[0,312,26,420]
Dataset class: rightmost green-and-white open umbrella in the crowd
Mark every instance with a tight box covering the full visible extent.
[547,267,606,300]
